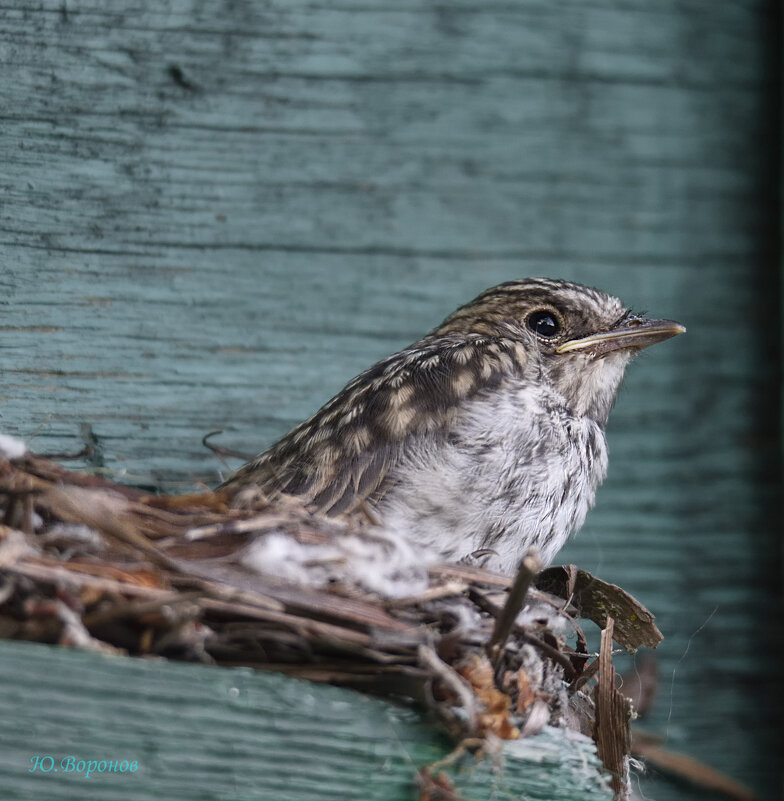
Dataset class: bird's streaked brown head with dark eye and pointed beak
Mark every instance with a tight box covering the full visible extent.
[433,278,686,425]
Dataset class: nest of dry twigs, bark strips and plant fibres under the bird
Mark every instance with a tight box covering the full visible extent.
[0,444,661,797]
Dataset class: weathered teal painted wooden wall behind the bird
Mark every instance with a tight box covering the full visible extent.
[0,0,779,799]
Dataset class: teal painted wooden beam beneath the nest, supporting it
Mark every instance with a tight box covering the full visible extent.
[0,642,612,801]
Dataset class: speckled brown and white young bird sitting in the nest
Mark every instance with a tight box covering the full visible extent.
[219,278,686,574]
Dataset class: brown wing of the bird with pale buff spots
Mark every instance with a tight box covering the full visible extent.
[223,336,526,515]
